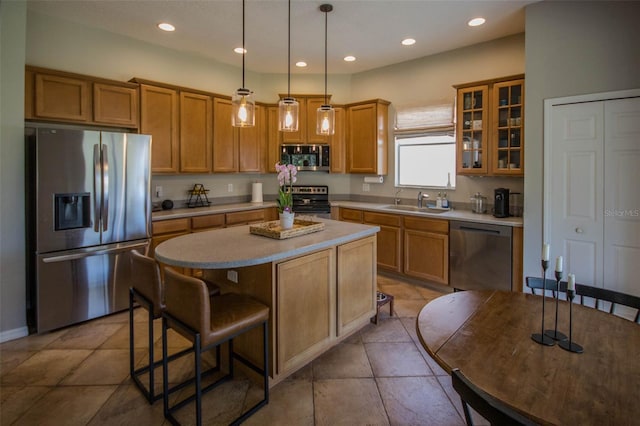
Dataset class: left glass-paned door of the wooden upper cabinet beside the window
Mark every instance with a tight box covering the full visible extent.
[456,85,489,174]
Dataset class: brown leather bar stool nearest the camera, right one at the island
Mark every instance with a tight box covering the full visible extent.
[162,268,269,425]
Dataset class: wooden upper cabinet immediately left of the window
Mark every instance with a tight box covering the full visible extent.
[346,99,389,175]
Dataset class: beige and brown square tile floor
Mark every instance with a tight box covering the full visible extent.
[0,276,484,426]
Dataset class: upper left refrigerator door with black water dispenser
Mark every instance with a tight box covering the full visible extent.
[33,128,100,253]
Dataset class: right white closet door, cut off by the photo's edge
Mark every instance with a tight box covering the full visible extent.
[604,98,640,296]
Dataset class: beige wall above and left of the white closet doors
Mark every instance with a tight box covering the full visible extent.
[524,1,640,286]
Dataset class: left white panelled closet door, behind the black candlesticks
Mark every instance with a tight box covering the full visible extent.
[545,102,604,287]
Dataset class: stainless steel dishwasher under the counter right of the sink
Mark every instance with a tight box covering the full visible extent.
[449,220,511,291]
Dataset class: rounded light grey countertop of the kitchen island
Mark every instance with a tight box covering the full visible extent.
[155,218,380,269]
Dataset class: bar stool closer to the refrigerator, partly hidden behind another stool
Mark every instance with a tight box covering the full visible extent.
[129,251,220,404]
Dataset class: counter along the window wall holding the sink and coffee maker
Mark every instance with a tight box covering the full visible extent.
[331,201,523,228]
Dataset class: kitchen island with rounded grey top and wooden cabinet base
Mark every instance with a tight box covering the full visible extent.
[155,218,380,386]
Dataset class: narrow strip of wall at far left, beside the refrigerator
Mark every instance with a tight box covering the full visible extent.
[0,1,27,342]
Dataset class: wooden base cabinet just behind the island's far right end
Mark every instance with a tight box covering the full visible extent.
[364,211,402,272]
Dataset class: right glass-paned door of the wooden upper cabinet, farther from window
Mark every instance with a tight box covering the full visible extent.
[491,80,524,175]
